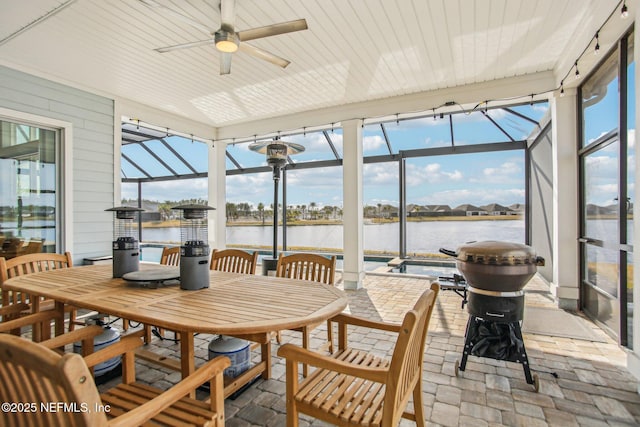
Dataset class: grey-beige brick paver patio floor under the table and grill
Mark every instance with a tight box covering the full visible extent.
[101,274,640,427]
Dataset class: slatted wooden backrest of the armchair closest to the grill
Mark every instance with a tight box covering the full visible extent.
[382,284,440,426]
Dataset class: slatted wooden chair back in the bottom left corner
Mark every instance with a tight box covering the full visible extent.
[0,334,107,427]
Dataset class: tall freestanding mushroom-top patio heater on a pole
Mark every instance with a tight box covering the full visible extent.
[249,137,304,276]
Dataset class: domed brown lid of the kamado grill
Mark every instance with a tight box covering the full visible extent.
[457,240,544,265]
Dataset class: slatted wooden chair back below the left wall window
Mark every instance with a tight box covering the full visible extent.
[0,252,73,306]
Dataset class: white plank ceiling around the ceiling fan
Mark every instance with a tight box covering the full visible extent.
[0,0,632,134]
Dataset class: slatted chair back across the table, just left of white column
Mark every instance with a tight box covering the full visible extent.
[276,253,336,285]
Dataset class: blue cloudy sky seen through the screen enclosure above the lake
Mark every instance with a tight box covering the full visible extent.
[122,103,548,208]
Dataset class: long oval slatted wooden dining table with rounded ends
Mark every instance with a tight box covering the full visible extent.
[3,264,348,396]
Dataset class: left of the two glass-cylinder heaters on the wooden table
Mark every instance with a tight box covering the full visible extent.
[106,206,144,278]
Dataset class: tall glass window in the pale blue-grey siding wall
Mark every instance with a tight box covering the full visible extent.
[0,120,60,258]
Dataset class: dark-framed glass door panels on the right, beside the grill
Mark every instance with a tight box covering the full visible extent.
[578,35,635,348]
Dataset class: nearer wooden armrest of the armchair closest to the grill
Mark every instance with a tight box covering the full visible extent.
[278,344,388,383]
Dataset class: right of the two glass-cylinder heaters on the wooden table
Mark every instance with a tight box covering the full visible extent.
[172,204,215,291]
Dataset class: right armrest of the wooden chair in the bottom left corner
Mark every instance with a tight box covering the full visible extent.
[109,356,231,427]
